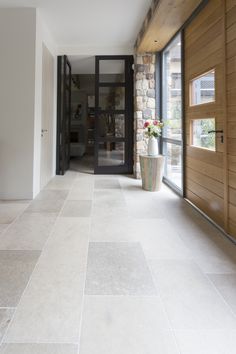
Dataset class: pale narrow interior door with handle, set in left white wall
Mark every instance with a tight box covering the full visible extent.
[40,45,54,189]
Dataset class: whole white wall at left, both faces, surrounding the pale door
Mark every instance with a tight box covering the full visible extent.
[0,8,56,199]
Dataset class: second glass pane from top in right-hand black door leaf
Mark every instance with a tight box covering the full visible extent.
[99,87,125,110]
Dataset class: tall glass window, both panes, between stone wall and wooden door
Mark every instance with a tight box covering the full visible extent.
[162,34,183,190]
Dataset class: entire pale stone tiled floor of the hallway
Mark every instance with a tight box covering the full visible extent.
[0,171,236,354]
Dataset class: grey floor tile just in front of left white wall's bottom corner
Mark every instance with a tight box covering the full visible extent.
[25,199,64,213]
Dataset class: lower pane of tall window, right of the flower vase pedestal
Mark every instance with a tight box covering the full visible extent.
[163,143,182,189]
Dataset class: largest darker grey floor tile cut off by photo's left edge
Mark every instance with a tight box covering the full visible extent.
[0,251,40,307]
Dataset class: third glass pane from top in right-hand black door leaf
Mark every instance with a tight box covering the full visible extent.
[99,113,125,138]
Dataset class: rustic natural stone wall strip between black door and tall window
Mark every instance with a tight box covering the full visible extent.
[134,53,156,178]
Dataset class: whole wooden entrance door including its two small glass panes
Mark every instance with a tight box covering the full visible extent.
[184,0,228,230]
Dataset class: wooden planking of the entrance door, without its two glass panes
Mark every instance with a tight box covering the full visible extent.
[185,0,226,228]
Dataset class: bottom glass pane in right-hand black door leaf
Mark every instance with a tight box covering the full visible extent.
[98,141,125,166]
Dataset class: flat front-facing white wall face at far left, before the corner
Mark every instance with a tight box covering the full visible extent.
[0,9,36,199]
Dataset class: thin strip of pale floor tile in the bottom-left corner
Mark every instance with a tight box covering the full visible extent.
[0,343,78,354]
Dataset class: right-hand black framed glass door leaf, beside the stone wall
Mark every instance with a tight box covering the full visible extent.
[94,56,133,174]
